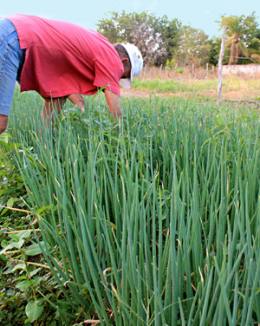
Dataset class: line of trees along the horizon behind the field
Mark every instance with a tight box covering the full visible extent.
[97,11,260,68]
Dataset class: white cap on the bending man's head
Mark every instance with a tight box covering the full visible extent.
[120,43,144,88]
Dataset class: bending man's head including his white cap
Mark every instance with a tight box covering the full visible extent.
[115,43,143,88]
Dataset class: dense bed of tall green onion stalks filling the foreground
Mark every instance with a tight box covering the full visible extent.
[2,91,260,325]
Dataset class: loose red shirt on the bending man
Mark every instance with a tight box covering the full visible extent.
[8,15,123,97]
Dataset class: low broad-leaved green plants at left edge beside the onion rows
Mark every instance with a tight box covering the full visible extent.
[0,134,76,326]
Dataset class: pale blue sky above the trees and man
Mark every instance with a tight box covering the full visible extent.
[0,0,260,37]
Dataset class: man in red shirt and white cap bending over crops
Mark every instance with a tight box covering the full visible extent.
[0,15,143,134]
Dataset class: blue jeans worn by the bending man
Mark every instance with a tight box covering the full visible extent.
[0,19,25,116]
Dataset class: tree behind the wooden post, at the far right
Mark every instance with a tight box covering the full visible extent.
[220,13,260,65]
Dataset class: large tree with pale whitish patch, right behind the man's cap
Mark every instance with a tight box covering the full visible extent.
[97,11,180,66]
